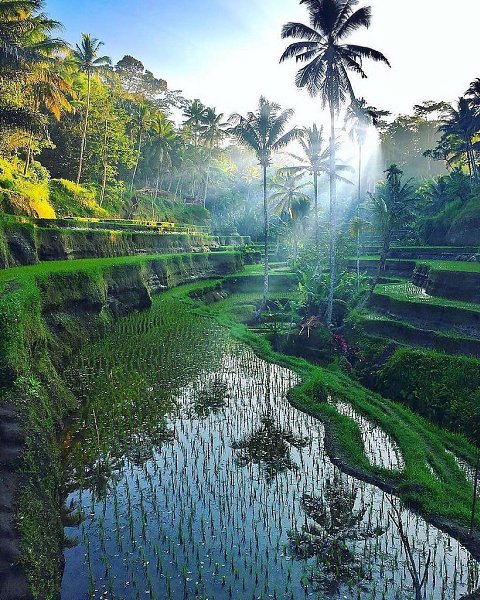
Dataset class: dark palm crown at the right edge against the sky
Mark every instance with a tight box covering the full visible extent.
[439,97,480,180]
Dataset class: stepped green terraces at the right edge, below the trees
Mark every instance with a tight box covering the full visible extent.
[350,247,480,357]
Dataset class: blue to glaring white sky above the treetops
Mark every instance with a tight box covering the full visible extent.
[46,0,480,125]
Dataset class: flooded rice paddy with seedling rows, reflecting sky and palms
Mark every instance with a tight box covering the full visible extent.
[62,294,479,600]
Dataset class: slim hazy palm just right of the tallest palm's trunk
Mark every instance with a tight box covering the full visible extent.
[345,98,390,287]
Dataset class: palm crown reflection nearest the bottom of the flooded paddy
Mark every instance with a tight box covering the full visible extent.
[289,475,385,594]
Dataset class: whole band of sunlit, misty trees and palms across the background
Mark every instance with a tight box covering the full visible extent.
[0,0,480,324]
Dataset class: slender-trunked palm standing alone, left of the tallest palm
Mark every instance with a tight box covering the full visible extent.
[232,96,299,314]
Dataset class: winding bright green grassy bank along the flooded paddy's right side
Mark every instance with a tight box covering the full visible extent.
[174,280,480,558]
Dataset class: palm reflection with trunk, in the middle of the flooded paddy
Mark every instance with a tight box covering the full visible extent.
[232,364,308,483]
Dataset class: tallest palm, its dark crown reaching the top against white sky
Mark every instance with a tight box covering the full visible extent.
[280,0,389,326]
